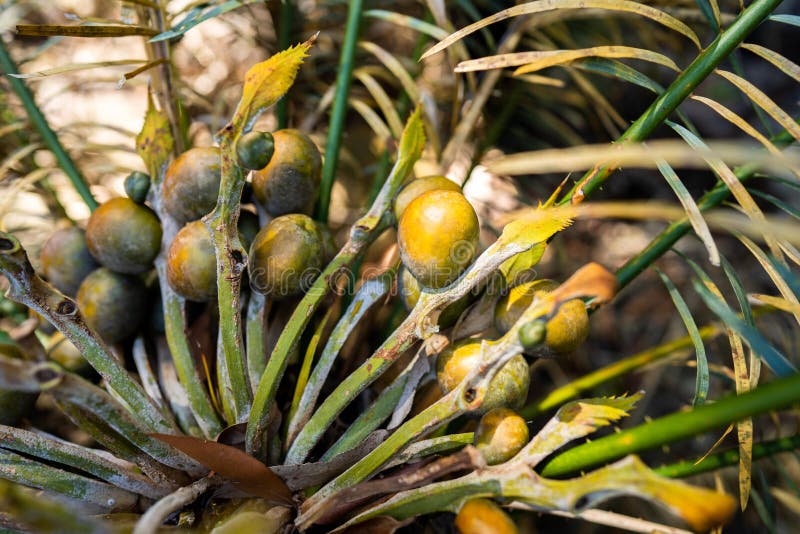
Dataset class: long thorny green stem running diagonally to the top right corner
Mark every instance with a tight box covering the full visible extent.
[560,0,781,204]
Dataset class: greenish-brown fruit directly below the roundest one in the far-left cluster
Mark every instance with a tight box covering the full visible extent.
[76,267,147,343]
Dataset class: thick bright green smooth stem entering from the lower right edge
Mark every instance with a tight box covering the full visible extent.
[542,374,800,477]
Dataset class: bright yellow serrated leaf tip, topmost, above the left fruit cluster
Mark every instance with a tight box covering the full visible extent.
[231,35,316,136]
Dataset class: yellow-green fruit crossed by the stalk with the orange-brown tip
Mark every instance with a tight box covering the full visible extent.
[494,280,589,353]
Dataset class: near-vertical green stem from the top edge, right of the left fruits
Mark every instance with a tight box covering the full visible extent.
[317,0,364,221]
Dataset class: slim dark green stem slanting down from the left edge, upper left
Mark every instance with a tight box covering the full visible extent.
[0,40,97,211]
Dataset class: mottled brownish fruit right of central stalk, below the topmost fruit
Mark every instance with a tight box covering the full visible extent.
[247,213,324,299]
